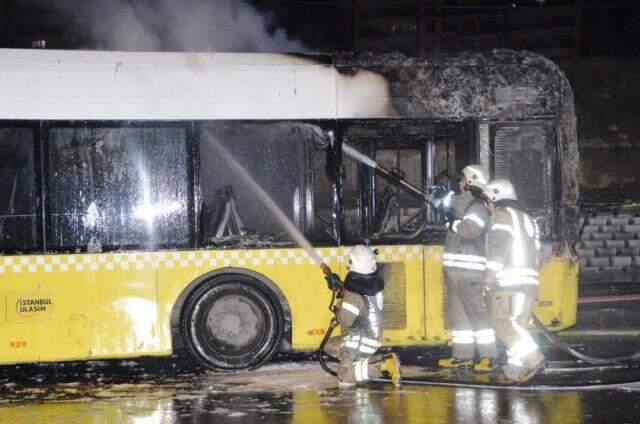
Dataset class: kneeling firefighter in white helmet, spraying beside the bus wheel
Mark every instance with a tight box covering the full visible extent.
[324,245,400,387]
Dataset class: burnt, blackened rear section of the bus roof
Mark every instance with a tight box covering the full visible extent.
[335,49,573,120]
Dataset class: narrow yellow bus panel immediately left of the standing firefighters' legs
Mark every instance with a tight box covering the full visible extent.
[424,246,451,345]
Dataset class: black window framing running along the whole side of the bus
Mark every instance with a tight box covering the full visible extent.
[0,117,561,254]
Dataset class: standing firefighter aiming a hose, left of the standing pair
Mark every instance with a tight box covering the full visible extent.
[438,165,498,372]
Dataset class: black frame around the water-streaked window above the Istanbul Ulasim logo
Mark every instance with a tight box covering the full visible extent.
[41,120,196,253]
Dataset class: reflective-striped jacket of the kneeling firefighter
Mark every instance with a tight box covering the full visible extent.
[338,290,383,356]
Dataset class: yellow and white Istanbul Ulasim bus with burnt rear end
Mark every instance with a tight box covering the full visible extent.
[0,50,577,369]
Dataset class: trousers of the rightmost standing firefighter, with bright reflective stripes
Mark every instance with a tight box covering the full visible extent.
[490,290,544,369]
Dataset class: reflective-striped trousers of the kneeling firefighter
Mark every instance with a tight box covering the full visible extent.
[324,336,384,384]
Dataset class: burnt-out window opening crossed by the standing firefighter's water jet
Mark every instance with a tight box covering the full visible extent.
[343,120,460,243]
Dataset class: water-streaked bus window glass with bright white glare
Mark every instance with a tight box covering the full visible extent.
[48,127,190,251]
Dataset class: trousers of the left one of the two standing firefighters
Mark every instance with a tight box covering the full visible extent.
[445,270,498,360]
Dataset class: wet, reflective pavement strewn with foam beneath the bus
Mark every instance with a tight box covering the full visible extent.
[0,338,640,424]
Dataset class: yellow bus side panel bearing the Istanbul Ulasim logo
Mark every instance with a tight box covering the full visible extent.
[0,253,170,362]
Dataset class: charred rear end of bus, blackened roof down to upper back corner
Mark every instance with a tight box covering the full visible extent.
[337,50,578,248]
